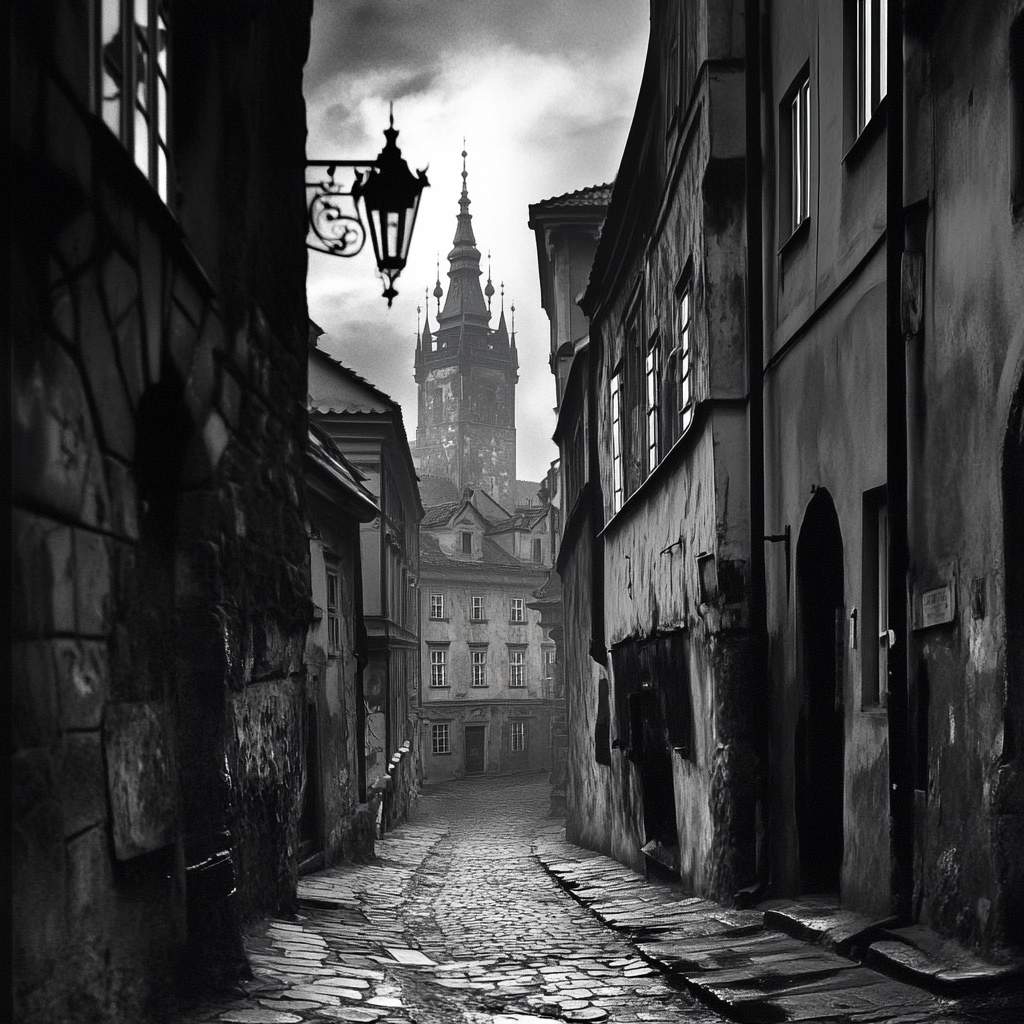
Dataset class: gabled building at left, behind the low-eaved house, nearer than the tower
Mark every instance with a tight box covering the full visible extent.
[309,347,423,827]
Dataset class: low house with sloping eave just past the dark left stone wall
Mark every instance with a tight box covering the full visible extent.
[298,420,380,873]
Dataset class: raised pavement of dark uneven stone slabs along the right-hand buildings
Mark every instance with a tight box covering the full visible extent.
[534,829,1024,1024]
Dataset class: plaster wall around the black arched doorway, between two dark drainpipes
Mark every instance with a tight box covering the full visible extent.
[764,3,890,914]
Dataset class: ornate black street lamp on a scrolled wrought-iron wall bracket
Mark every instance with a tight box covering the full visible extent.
[306,110,430,306]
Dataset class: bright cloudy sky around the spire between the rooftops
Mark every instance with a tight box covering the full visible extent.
[304,0,649,480]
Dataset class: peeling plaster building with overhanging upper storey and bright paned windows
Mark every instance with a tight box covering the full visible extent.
[564,2,760,897]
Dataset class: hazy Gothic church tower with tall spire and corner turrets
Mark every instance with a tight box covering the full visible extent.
[413,150,519,512]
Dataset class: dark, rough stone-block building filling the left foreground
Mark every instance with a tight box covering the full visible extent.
[9,0,311,1022]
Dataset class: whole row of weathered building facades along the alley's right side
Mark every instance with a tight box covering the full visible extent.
[542,0,1024,948]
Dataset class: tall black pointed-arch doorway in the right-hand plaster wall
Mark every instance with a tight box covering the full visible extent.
[795,488,844,893]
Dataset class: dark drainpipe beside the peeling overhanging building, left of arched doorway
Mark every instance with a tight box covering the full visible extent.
[743,0,768,886]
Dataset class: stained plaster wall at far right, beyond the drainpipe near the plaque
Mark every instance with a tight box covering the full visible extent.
[908,2,1024,946]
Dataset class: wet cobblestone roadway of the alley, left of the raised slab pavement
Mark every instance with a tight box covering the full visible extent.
[179,774,720,1024]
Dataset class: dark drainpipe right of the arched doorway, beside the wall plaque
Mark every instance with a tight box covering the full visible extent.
[886,3,913,920]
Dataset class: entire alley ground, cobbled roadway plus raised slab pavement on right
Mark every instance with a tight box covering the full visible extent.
[175,775,1015,1024]
